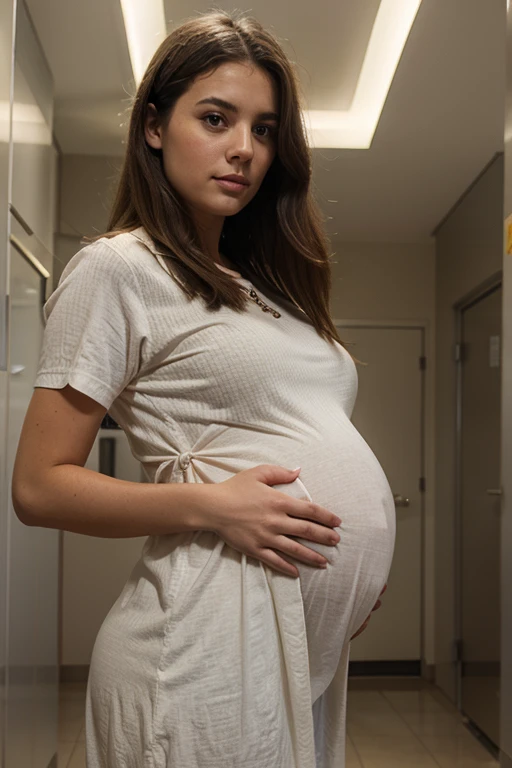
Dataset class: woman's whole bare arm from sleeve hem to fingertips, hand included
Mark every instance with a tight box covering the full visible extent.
[12,385,340,577]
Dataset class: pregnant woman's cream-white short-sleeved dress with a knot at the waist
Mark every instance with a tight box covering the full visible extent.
[35,228,395,768]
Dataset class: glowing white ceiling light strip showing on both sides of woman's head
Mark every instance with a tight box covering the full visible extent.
[120,0,421,149]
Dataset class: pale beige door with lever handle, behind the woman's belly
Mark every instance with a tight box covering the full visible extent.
[340,320,424,674]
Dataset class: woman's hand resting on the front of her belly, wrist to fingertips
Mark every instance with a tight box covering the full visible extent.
[203,464,340,576]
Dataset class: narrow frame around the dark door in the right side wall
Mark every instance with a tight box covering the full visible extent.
[453,269,503,712]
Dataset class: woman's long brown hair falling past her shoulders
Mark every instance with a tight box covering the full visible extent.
[91,10,346,348]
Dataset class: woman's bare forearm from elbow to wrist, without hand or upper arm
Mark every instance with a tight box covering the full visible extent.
[16,464,215,538]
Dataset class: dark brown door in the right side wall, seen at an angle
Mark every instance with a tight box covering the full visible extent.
[458,286,502,745]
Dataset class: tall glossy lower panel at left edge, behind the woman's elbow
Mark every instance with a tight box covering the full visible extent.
[6,237,59,768]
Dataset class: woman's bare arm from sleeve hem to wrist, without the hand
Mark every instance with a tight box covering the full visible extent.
[12,385,209,538]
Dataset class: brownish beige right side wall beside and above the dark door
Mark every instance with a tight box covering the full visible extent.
[435,156,503,701]
